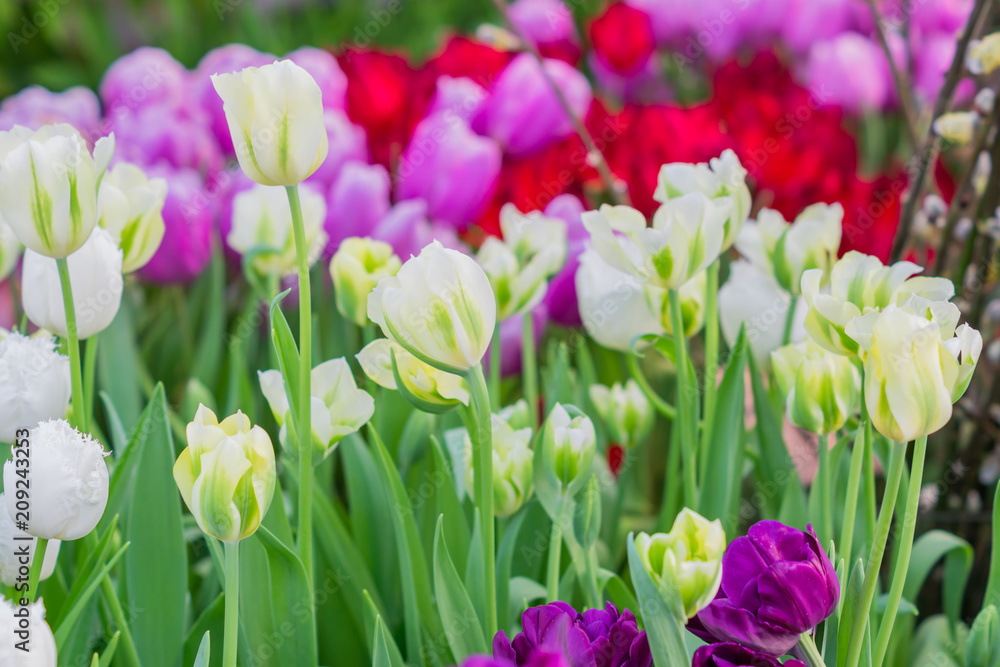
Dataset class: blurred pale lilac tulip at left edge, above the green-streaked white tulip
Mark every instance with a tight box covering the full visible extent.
[0,86,101,139]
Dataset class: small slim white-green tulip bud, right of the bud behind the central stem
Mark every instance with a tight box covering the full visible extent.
[541,403,597,496]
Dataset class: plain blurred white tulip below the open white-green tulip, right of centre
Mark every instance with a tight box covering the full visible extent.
[719,260,808,368]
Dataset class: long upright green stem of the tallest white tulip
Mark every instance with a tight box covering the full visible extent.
[285,185,313,590]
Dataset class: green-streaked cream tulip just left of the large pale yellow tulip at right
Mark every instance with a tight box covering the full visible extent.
[771,340,861,435]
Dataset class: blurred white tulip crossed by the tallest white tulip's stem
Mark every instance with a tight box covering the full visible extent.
[226,185,327,278]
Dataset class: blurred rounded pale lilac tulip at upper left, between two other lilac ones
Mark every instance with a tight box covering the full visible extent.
[99,46,190,116]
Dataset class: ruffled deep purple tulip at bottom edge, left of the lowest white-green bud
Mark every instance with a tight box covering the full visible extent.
[493,602,653,667]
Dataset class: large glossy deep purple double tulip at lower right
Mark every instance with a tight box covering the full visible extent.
[688,521,840,656]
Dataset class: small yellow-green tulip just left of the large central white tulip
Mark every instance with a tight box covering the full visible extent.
[330,236,403,327]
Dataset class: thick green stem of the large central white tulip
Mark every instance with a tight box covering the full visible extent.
[466,364,497,637]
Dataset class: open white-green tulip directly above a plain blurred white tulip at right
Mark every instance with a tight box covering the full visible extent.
[736,204,844,295]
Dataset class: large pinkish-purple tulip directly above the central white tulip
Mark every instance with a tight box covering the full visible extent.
[396,113,502,229]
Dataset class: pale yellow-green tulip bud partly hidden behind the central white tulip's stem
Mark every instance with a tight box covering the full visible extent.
[464,415,534,517]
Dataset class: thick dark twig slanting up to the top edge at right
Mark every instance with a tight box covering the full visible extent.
[889,0,992,262]
